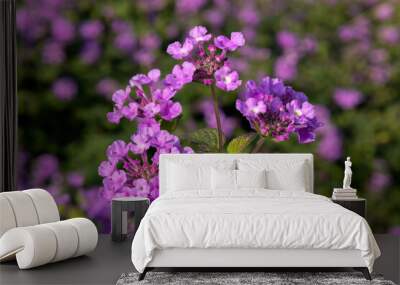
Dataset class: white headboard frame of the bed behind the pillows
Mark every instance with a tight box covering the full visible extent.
[159,153,314,195]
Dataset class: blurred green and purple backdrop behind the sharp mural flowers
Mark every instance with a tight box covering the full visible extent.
[17,0,400,235]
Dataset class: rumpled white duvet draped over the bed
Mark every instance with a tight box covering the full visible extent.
[132,189,380,272]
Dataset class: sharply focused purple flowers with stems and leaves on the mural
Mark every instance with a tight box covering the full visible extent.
[99,26,321,200]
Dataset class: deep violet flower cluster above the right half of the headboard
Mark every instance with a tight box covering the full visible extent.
[236,77,321,143]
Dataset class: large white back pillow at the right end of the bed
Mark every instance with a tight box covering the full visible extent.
[238,159,309,192]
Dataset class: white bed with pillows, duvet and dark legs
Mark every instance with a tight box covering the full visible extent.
[132,154,380,278]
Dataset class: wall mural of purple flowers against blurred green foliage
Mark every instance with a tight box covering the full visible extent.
[17,0,400,234]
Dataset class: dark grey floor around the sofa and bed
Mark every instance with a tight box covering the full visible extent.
[0,235,400,285]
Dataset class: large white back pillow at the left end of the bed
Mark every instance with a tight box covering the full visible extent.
[167,163,211,191]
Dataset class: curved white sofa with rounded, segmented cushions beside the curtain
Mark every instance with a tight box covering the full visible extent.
[0,189,98,269]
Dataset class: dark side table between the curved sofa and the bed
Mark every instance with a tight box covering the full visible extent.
[111,197,150,241]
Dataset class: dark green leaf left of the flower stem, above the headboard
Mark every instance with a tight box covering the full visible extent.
[188,128,224,153]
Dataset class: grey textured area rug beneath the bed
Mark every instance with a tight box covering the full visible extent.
[117,272,395,285]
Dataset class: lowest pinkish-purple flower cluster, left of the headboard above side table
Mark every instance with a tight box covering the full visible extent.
[98,119,193,200]
